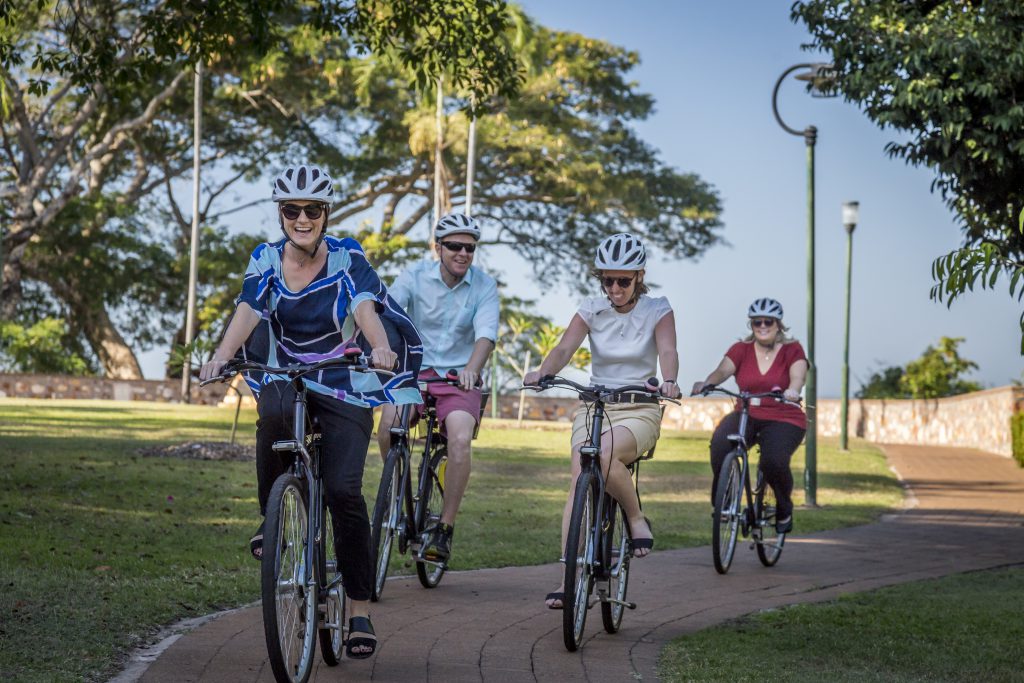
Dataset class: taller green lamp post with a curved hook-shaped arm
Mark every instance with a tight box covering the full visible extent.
[771,63,831,506]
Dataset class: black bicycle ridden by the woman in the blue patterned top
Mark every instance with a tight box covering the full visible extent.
[200,347,393,683]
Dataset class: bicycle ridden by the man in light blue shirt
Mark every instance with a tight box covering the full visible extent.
[370,371,487,602]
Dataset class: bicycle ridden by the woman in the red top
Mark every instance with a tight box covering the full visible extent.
[700,385,800,573]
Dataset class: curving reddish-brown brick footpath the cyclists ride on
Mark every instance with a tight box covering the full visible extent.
[130,445,1024,683]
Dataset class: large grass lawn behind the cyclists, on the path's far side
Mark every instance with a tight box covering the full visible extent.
[0,399,901,681]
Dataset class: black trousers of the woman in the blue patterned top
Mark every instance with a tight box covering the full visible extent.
[256,382,374,600]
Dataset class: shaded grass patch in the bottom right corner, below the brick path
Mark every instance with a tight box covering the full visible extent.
[658,567,1024,683]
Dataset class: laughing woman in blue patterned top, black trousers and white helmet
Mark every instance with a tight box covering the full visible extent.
[200,165,423,658]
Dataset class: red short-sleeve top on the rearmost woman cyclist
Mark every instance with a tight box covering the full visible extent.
[725,341,807,429]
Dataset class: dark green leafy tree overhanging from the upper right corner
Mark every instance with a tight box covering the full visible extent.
[792,0,1024,353]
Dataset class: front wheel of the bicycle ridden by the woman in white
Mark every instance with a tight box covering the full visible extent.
[562,472,597,652]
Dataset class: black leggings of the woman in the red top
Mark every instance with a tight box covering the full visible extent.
[711,412,807,519]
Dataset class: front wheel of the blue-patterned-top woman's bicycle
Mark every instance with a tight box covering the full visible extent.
[260,474,317,683]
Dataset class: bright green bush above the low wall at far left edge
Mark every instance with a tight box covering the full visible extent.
[0,317,93,375]
